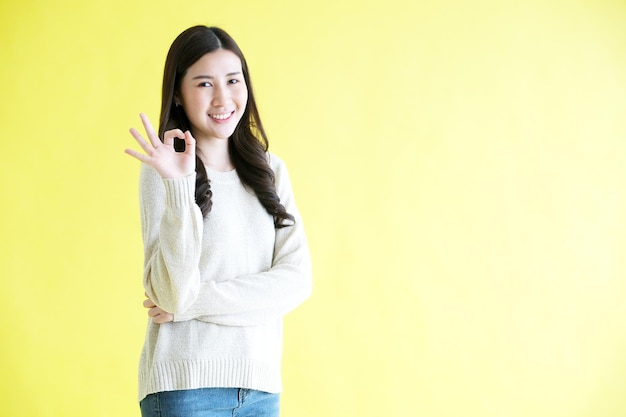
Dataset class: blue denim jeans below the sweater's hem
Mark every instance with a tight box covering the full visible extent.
[139,388,280,417]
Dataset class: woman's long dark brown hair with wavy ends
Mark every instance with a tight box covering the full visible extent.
[159,26,294,229]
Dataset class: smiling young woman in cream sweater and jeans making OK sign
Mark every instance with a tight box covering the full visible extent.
[126,26,311,417]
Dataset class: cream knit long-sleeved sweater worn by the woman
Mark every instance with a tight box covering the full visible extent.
[139,154,311,400]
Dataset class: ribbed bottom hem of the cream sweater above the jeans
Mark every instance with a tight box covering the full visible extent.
[139,359,282,401]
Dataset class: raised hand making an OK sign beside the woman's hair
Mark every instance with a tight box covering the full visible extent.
[125,113,196,179]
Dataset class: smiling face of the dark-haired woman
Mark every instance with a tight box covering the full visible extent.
[177,49,248,140]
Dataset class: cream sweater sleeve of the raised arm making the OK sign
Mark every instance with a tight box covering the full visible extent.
[139,165,203,314]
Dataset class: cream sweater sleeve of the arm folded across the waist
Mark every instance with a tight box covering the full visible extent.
[174,156,312,326]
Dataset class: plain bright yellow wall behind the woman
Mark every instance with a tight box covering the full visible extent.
[0,0,626,417]
